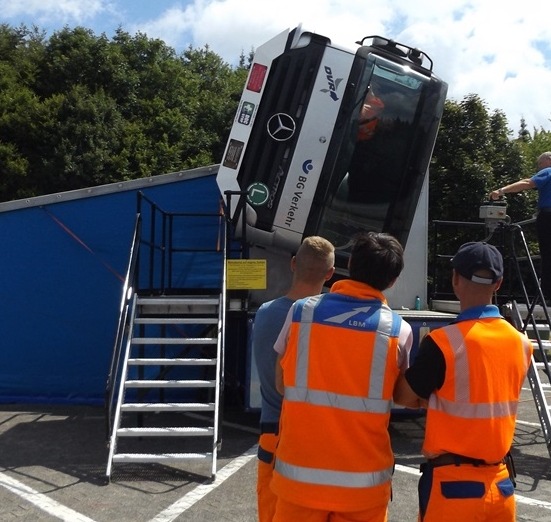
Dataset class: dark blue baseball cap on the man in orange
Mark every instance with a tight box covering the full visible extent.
[452,242,503,285]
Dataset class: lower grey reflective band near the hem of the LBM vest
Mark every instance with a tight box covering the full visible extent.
[275,458,393,488]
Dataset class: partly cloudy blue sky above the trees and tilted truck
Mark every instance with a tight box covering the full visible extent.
[0,0,551,133]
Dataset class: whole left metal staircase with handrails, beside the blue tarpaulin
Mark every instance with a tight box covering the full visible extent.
[106,195,226,480]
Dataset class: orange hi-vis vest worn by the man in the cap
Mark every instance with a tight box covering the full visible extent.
[423,318,533,462]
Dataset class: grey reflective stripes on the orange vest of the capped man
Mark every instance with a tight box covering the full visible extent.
[429,324,531,419]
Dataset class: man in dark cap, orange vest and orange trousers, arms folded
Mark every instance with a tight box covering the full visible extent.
[394,242,533,522]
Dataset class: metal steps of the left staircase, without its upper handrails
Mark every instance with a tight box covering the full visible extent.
[107,295,223,477]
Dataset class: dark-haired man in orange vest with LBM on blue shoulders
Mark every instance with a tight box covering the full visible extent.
[271,232,412,522]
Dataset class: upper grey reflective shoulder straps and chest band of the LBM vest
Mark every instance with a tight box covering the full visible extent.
[285,296,397,413]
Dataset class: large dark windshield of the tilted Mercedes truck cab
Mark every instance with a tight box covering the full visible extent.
[319,56,430,260]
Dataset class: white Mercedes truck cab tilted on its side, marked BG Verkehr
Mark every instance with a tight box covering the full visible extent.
[217,26,447,270]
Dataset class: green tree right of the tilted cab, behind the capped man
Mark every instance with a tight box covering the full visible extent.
[429,94,524,295]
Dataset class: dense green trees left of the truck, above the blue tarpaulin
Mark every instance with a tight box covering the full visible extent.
[0,25,247,200]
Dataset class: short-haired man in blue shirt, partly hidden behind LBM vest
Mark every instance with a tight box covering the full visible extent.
[252,236,335,522]
